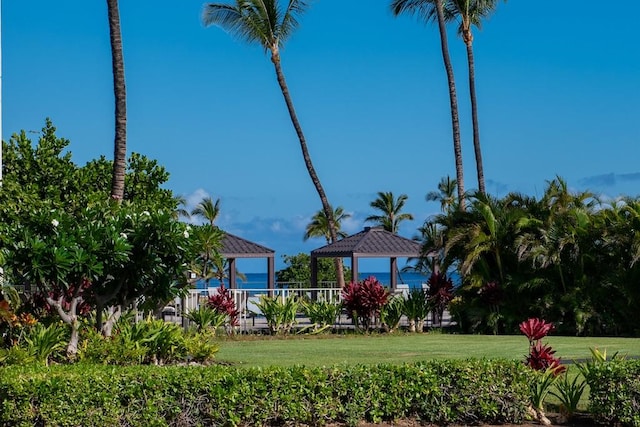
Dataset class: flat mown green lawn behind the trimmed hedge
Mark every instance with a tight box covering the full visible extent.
[217,333,640,366]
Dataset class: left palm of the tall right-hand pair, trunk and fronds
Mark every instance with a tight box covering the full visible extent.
[391,0,465,210]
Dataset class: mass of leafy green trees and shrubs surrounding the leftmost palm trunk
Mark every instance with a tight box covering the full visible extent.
[0,121,219,356]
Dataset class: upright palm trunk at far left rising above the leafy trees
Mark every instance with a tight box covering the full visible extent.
[107,0,127,200]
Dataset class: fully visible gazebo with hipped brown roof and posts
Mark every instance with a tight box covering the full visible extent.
[311,227,420,291]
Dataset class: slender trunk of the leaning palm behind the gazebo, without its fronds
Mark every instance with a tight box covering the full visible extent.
[271,46,344,287]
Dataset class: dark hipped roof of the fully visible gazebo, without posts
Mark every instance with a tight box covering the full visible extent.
[311,227,420,258]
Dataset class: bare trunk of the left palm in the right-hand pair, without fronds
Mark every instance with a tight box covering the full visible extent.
[435,0,465,210]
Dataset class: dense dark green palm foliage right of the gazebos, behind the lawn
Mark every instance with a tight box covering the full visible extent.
[418,178,640,335]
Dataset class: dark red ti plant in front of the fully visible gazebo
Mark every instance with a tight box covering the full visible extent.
[342,276,389,330]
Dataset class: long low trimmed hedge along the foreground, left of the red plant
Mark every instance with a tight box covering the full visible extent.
[0,360,530,426]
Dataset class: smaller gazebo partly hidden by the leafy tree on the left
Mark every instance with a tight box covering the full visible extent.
[220,231,275,291]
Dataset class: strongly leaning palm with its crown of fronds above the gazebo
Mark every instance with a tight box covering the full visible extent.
[203,0,337,242]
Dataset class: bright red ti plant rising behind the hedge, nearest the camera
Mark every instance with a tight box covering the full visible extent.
[520,318,567,376]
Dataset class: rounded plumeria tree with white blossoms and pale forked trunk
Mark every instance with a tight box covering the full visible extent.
[4,202,192,356]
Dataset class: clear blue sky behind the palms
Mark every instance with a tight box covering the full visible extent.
[2,0,640,272]
